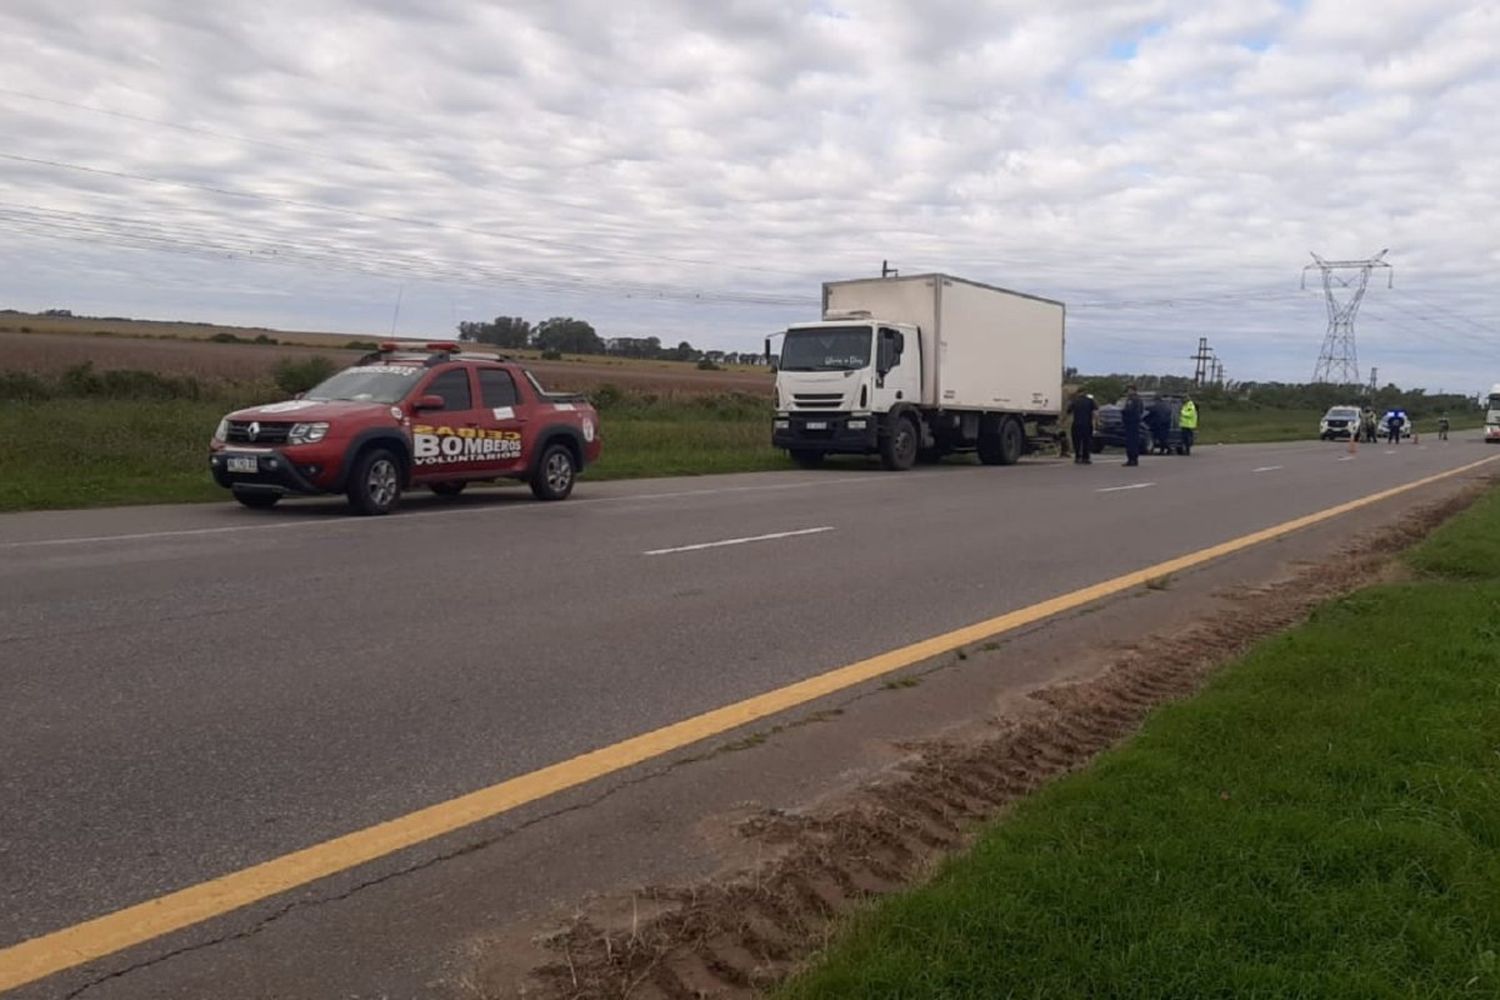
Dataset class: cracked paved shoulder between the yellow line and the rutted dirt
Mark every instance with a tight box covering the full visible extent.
[41,464,1494,997]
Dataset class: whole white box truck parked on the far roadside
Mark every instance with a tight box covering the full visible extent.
[767,274,1065,469]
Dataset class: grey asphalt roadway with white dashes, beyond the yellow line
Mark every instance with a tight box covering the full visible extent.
[0,438,1500,983]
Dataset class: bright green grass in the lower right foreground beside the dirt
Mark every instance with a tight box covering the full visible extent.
[782,493,1500,1000]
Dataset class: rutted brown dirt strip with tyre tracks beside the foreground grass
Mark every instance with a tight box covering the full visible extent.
[501,473,1484,999]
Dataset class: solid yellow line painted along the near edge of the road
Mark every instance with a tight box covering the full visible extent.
[0,456,1500,991]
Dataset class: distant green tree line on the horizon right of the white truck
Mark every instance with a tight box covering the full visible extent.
[1068,369,1479,417]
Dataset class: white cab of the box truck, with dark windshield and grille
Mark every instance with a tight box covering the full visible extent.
[771,316,923,466]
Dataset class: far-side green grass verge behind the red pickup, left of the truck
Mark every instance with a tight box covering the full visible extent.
[0,399,791,511]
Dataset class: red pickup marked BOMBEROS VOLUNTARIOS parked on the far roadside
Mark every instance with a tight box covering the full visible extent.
[209,343,600,514]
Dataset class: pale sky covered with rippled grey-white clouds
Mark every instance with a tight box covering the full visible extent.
[0,0,1500,391]
